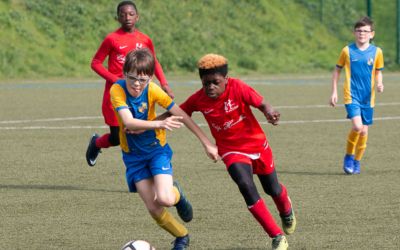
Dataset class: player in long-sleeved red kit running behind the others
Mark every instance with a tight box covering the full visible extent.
[86,1,174,166]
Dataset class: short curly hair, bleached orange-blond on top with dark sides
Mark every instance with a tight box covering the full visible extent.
[197,54,228,78]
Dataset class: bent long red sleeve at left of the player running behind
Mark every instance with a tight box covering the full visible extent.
[91,36,118,82]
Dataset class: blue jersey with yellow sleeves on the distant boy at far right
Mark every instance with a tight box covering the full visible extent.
[336,43,384,107]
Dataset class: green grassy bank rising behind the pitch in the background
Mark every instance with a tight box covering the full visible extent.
[0,0,397,79]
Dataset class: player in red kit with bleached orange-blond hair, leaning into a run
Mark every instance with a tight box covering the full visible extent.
[181,54,296,249]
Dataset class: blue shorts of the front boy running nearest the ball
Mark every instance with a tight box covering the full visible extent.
[122,144,173,193]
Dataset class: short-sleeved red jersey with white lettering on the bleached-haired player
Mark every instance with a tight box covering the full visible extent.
[181,78,267,155]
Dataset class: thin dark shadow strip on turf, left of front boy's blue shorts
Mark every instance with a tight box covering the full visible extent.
[0,184,129,193]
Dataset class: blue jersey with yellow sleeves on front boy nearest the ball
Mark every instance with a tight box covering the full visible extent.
[110,80,175,154]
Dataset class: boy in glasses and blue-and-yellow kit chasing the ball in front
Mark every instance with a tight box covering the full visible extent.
[110,49,218,250]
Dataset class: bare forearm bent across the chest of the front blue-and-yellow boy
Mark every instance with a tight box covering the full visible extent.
[118,109,183,131]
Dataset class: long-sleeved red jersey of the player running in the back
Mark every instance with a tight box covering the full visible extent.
[91,28,167,85]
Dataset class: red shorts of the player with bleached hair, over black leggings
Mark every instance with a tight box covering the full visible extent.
[222,144,275,175]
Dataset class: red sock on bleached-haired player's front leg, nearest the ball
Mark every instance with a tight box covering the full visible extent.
[249,199,283,238]
